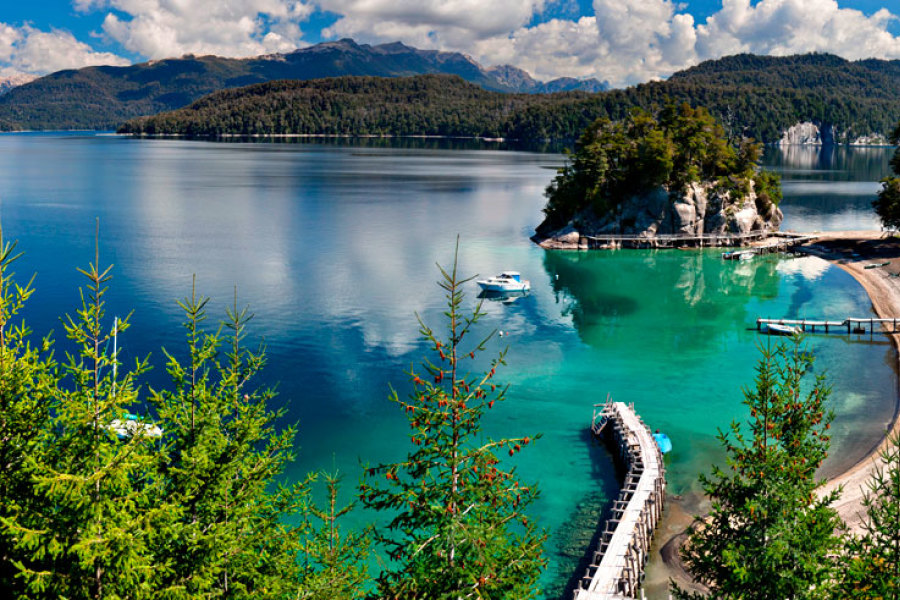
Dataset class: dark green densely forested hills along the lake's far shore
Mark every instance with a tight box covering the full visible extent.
[119,54,900,142]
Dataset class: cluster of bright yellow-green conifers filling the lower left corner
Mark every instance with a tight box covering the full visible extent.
[0,240,324,600]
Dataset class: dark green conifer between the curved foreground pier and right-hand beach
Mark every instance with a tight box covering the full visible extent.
[673,341,840,599]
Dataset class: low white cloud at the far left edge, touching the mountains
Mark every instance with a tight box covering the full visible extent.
[0,23,130,77]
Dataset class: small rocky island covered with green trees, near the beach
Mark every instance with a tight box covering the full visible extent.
[533,102,782,248]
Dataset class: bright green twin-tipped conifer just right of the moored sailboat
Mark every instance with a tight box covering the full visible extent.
[151,288,306,598]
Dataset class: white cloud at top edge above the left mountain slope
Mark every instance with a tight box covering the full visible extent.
[88,0,313,58]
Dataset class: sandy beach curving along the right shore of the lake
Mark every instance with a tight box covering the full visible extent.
[644,231,900,598]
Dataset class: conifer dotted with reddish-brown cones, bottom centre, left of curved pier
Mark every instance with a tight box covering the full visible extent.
[360,245,545,600]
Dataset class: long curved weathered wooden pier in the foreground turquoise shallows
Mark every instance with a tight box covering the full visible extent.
[574,400,666,600]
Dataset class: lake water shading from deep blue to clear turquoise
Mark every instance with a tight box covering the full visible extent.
[0,135,897,582]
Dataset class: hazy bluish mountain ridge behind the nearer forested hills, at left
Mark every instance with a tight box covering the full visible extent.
[0,39,604,129]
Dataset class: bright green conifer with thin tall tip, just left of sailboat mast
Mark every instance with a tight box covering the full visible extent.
[4,226,155,598]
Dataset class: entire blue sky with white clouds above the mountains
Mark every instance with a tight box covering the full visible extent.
[0,0,900,87]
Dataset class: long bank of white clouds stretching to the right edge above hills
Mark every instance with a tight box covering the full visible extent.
[317,0,900,85]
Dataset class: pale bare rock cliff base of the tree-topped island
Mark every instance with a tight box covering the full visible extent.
[532,183,783,249]
